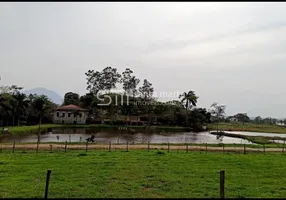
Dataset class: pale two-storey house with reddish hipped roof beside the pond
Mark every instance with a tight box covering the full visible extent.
[53,104,88,124]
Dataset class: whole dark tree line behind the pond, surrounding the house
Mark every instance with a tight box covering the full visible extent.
[0,66,282,130]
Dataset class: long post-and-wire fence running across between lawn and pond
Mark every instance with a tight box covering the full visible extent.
[0,141,285,154]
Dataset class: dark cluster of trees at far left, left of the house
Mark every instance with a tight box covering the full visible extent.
[0,85,57,127]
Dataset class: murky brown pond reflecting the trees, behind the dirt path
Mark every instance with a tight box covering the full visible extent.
[2,128,260,144]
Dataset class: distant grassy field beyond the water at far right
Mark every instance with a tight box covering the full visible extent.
[208,122,286,133]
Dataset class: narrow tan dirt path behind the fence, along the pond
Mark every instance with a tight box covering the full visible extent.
[1,143,282,153]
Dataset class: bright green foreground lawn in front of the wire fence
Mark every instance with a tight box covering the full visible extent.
[0,150,286,198]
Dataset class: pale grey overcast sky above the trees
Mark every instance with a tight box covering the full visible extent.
[0,2,286,118]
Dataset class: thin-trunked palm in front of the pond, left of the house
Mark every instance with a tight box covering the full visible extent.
[33,95,51,142]
